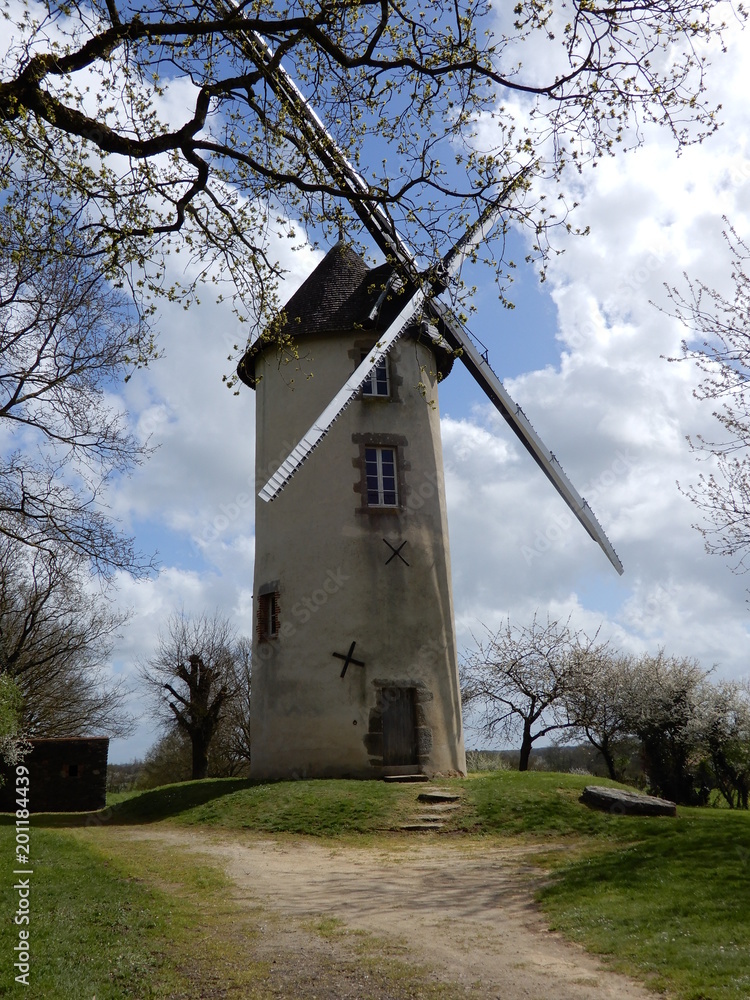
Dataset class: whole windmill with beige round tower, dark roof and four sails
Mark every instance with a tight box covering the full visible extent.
[238,33,622,778]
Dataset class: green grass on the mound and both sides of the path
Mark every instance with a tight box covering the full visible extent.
[0,771,750,1000]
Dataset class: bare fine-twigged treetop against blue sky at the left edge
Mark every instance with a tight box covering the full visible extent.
[0,201,154,575]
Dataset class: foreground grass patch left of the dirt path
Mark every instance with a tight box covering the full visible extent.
[0,826,280,1000]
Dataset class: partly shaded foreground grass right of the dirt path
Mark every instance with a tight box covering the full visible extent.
[540,809,750,1000]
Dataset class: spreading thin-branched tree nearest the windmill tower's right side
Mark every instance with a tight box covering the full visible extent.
[464,615,603,771]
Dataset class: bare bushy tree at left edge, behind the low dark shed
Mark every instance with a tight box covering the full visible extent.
[0,535,132,737]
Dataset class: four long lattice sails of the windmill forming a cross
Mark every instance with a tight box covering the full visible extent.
[247,31,623,574]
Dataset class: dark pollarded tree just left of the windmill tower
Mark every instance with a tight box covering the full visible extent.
[141,612,253,779]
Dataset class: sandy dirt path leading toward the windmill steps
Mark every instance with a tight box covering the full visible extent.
[120,827,653,1000]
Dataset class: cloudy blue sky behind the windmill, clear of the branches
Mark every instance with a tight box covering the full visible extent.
[33,7,750,761]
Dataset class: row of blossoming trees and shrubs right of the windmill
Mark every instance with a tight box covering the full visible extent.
[462,616,750,809]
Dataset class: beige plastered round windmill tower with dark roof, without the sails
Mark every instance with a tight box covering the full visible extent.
[240,244,465,779]
